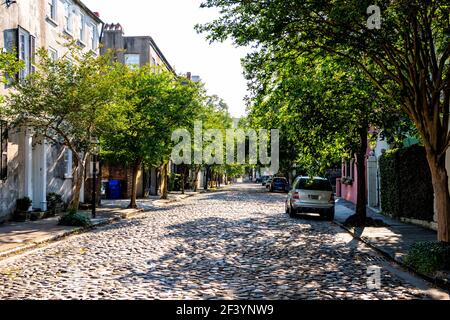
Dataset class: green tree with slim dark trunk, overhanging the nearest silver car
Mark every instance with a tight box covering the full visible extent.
[246,55,398,225]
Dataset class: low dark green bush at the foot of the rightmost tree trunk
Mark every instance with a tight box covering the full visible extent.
[405,242,450,275]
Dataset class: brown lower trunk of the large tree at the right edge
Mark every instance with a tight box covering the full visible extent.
[427,150,450,242]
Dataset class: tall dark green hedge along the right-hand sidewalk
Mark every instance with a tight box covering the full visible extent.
[379,145,434,221]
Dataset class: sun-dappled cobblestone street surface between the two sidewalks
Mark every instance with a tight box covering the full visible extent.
[0,185,444,299]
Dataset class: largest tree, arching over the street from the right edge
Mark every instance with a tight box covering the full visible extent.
[197,0,450,242]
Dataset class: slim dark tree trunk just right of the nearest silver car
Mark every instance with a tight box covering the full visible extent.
[356,126,367,226]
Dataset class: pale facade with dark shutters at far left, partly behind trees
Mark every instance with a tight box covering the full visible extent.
[0,0,103,221]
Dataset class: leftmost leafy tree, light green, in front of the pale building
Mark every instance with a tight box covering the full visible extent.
[6,44,124,209]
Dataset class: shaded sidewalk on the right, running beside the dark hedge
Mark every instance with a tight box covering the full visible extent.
[334,198,450,286]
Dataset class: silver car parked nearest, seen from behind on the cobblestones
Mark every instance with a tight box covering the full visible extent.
[286,176,334,221]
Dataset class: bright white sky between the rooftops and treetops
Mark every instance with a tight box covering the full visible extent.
[82,0,248,117]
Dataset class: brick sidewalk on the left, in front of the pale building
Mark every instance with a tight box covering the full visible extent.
[0,208,138,259]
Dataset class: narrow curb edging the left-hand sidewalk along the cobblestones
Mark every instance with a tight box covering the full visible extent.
[0,209,143,260]
